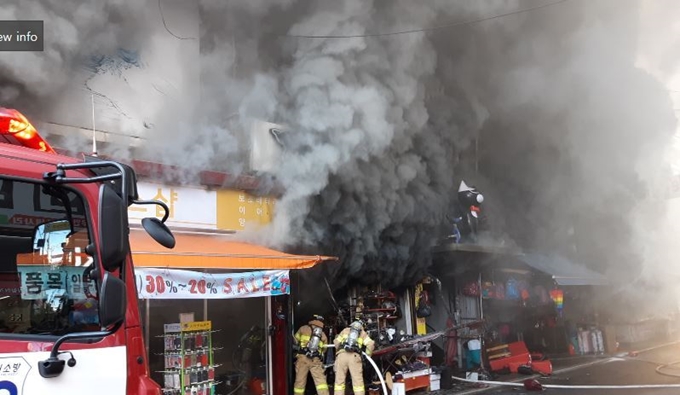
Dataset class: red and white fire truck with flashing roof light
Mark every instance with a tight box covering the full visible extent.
[0,108,175,395]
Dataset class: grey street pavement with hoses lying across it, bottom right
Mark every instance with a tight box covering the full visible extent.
[432,341,680,395]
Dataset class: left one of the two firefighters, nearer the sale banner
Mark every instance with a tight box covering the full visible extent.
[293,315,329,395]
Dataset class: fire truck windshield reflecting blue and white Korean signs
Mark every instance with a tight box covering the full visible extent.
[0,177,100,337]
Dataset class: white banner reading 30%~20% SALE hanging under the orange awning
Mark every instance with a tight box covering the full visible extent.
[135,268,290,299]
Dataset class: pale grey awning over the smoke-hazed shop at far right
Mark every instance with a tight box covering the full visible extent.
[520,254,608,286]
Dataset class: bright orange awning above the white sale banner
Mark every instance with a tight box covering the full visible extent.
[130,229,337,270]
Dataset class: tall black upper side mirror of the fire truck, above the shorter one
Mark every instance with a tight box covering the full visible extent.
[99,184,129,272]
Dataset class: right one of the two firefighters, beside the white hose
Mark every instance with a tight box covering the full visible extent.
[333,320,375,395]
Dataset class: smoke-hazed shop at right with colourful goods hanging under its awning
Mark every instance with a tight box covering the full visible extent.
[428,246,611,369]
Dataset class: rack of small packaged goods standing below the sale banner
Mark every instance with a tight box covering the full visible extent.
[162,321,217,395]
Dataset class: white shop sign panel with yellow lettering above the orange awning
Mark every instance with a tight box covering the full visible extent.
[128,182,217,229]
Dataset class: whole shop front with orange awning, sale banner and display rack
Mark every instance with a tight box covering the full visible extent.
[130,229,333,395]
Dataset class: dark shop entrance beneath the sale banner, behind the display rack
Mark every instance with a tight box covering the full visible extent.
[140,297,271,395]
